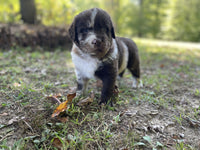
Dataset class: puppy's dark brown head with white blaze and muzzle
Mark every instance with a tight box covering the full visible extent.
[69,8,115,58]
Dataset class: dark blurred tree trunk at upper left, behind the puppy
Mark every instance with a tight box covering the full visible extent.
[20,0,36,24]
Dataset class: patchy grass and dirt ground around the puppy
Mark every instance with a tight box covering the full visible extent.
[0,39,200,150]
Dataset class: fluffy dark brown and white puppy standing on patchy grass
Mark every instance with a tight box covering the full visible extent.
[69,8,140,104]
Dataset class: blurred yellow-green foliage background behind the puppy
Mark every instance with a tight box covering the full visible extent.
[0,0,200,42]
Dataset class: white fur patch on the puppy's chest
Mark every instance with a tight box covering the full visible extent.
[71,44,100,79]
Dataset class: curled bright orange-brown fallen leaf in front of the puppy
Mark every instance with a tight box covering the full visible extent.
[51,93,76,118]
